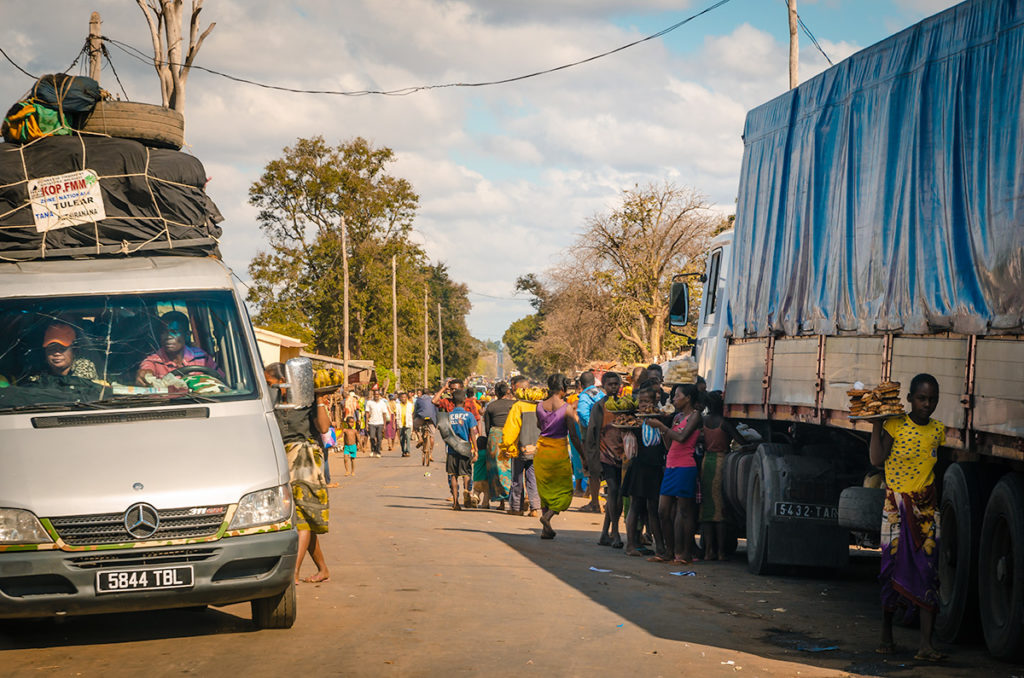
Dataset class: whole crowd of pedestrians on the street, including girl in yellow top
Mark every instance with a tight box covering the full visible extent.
[265,364,945,661]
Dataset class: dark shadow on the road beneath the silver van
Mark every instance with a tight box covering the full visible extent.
[0,607,256,650]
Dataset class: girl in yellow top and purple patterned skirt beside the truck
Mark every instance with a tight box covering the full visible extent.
[869,374,946,662]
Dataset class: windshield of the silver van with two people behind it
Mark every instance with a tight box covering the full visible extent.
[0,290,259,414]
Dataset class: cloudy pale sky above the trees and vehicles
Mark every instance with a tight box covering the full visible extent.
[0,0,955,346]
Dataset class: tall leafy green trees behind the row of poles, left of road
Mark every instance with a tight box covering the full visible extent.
[249,136,476,385]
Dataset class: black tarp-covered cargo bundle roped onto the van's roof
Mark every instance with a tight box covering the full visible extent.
[0,135,223,260]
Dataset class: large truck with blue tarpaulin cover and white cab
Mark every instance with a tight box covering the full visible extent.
[670,0,1024,658]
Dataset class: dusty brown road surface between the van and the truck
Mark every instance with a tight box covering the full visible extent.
[0,453,1024,678]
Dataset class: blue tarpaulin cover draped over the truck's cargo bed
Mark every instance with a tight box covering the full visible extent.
[727,0,1024,337]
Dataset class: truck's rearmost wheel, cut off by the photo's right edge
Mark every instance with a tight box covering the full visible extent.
[978,473,1024,660]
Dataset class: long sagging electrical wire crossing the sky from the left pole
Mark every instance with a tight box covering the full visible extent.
[99,0,730,96]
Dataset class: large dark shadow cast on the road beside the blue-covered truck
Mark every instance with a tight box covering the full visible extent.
[440,525,983,676]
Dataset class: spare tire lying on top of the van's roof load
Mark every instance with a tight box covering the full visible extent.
[82,101,185,151]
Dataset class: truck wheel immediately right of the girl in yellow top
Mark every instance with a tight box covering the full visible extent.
[937,464,983,643]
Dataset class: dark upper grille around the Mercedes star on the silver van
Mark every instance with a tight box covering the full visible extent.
[50,506,227,546]
